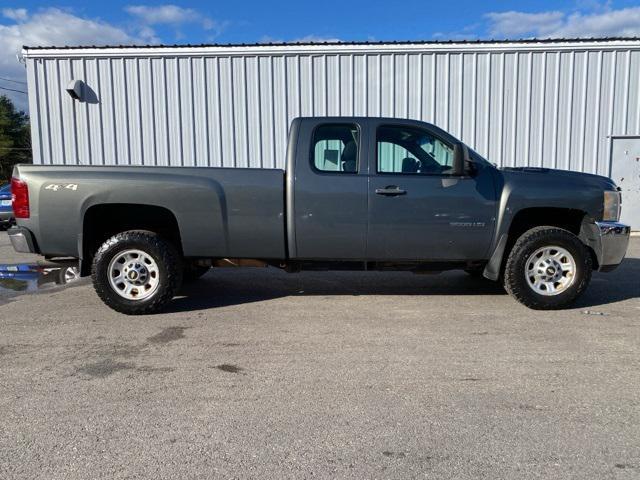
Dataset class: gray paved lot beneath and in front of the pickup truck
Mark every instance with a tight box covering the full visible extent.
[0,233,640,479]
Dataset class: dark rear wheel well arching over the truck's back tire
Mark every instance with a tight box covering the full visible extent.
[80,203,182,276]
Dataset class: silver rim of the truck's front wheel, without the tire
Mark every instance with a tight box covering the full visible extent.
[524,245,576,296]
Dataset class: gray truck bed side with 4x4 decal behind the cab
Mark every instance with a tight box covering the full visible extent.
[14,165,286,259]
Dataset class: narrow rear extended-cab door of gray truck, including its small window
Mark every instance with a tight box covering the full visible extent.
[287,118,368,260]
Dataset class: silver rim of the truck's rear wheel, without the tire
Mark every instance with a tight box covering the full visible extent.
[108,250,160,300]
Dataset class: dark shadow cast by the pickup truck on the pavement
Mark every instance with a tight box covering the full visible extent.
[167,258,640,312]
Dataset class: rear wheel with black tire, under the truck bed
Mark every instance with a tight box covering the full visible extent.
[91,230,183,315]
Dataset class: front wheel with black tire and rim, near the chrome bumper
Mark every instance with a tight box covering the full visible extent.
[504,227,593,310]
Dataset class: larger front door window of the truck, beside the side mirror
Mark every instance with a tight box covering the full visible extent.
[376,126,453,175]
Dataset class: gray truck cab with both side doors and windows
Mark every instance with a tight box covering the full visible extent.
[287,118,498,262]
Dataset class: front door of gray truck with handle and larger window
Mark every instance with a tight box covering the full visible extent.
[367,120,496,261]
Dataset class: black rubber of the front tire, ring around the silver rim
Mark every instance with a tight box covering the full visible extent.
[505,227,592,310]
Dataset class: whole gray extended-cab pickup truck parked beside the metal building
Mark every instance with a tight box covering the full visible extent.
[9,117,630,314]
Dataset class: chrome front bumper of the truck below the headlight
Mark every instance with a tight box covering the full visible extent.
[589,222,631,272]
